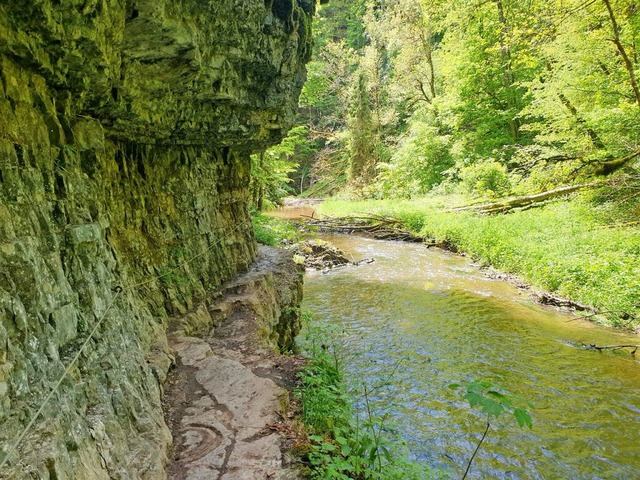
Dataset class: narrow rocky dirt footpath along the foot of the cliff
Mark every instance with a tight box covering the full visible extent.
[165,247,299,480]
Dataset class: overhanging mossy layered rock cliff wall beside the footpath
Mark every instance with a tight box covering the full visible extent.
[0,0,314,479]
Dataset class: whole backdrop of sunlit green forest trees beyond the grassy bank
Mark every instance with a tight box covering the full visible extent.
[288,0,640,198]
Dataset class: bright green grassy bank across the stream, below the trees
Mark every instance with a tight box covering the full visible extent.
[319,196,640,327]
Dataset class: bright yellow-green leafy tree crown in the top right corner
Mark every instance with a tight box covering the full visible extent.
[522,1,640,167]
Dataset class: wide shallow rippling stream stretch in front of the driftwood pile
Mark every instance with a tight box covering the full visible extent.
[305,236,640,479]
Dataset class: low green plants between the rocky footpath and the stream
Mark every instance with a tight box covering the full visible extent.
[296,317,439,480]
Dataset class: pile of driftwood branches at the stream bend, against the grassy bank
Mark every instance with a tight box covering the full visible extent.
[305,215,423,242]
